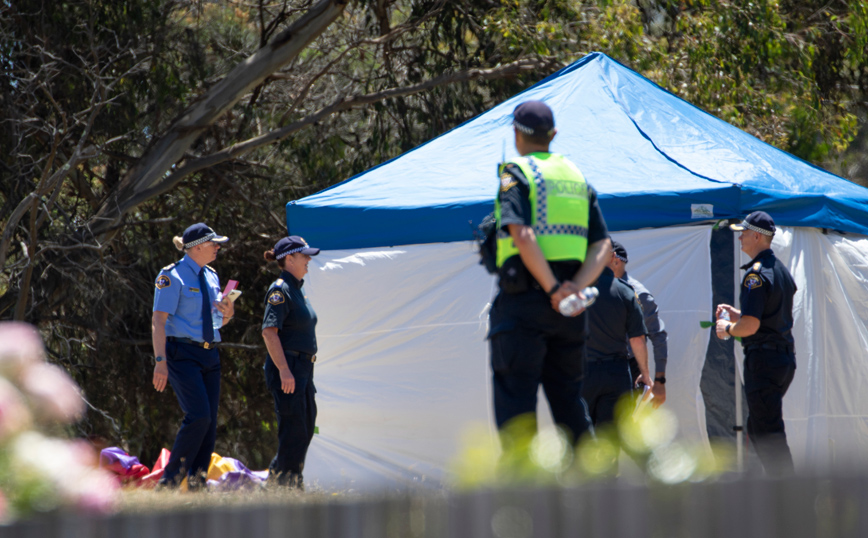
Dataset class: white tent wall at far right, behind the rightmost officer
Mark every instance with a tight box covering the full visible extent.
[735,228,868,469]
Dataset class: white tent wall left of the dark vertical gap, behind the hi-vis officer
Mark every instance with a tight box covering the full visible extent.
[305,226,712,489]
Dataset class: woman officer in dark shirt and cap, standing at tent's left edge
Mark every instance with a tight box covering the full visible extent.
[262,235,319,489]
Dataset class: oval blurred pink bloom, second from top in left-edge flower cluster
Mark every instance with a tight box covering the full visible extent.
[21,362,84,422]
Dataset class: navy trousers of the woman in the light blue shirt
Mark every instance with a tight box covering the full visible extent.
[161,342,220,484]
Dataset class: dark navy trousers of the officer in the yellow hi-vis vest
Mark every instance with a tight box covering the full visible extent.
[489,289,590,441]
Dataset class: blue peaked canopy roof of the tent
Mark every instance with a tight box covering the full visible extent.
[286,53,868,249]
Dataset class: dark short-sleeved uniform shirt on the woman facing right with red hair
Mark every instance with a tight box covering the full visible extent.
[262,271,317,355]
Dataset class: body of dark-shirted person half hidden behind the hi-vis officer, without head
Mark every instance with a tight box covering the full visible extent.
[582,262,653,427]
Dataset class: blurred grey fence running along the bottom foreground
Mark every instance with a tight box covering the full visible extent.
[0,474,868,538]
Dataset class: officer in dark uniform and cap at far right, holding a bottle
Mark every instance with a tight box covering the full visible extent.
[715,211,796,476]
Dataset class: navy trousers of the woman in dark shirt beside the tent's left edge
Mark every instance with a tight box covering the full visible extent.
[265,350,317,485]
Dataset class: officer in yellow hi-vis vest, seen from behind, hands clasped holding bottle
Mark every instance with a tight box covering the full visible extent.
[488,101,612,443]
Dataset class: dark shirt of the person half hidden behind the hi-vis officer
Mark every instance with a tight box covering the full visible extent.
[587,267,648,360]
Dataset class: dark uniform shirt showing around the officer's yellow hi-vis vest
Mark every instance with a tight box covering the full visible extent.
[498,159,609,281]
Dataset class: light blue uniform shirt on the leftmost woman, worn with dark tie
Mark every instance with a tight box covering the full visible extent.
[154,256,223,342]
